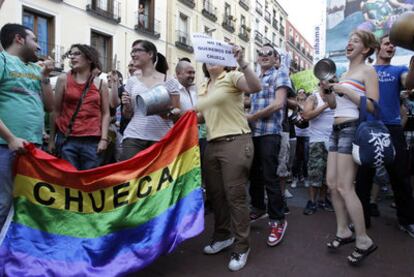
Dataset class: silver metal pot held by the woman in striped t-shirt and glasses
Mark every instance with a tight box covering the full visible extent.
[135,85,172,115]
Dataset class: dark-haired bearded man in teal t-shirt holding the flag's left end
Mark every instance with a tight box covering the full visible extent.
[0,24,53,231]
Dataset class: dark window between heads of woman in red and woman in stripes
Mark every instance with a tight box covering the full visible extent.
[91,31,114,72]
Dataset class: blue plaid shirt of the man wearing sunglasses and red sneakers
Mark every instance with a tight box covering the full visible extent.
[250,67,292,137]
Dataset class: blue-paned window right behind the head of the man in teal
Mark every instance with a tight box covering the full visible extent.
[23,10,57,57]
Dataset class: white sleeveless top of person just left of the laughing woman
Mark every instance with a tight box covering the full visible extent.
[309,92,335,142]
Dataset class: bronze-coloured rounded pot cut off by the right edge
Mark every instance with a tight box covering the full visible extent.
[390,12,414,51]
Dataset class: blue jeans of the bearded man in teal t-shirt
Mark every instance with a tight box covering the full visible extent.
[0,145,15,230]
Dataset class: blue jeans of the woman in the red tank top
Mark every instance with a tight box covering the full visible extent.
[56,133,102,170]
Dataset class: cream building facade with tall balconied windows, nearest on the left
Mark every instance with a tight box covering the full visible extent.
[0,0,167,76]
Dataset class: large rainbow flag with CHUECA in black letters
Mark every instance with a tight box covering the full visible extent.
[0,112,204,276]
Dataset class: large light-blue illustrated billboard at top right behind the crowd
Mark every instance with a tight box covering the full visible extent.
[326,0,414,72]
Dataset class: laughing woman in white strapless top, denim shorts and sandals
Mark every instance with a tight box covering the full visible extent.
[322,30,379,265]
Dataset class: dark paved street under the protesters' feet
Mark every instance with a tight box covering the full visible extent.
[131,188,414,277]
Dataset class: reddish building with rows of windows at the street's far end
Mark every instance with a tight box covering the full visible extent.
[286,20,314,72]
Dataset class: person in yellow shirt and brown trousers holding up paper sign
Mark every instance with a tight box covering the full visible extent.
[197,46,261,271]
